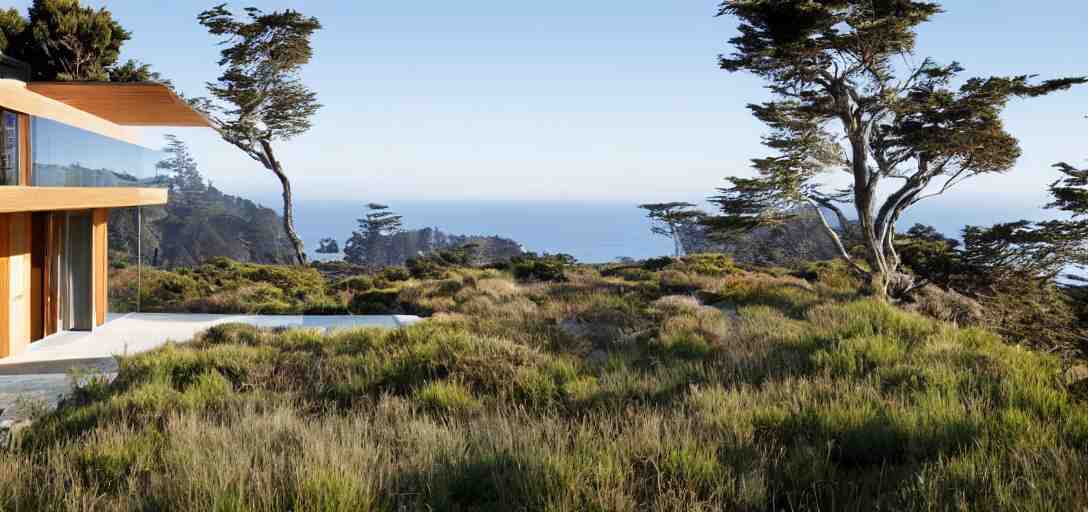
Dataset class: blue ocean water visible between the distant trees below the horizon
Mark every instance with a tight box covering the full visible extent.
[276,200,1042,263]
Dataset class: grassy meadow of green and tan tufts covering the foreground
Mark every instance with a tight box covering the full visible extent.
[0,255,1088,511]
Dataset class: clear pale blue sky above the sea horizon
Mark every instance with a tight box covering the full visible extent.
[15,0,1088,208]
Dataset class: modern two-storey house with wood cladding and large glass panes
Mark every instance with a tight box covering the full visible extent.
[0,54,208,358]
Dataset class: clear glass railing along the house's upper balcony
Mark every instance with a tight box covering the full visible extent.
[30,117,166,187]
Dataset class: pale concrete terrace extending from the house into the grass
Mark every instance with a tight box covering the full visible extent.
[0,313,420,421]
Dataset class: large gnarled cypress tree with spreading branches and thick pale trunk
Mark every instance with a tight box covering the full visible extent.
[714,0,1086,296]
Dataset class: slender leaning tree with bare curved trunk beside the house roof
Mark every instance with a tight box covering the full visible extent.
[194,4,321,264]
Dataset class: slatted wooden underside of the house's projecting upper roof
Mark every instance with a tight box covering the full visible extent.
[26,82,211,127]
